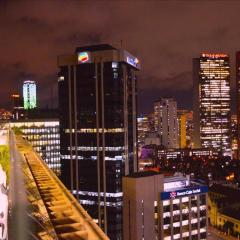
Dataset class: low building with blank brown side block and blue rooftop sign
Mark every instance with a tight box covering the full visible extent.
[123,172,208,240]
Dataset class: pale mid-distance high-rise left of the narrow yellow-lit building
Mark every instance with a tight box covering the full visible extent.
[154,98,178,148]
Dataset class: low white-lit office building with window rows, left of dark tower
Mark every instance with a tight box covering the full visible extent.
[10,119,61,176]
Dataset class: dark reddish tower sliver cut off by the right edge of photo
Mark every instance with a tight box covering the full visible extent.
[236,51,240,159]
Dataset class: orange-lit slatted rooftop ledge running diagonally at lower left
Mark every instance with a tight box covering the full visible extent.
[14,135,109,240]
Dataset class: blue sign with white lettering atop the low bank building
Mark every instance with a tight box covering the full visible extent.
[161,186,208,200]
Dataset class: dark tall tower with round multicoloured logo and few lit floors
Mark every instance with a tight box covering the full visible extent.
[58,44,140,239]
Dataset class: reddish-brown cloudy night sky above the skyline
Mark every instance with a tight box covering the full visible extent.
[0,0,240,113]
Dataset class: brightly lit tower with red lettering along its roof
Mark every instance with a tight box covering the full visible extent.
[193,53,231,156]
